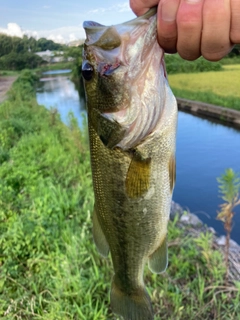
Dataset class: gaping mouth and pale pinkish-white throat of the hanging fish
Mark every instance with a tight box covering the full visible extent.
[83,7,166,150]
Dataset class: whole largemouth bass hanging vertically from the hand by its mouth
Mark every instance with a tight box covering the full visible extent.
[82,9,177,320]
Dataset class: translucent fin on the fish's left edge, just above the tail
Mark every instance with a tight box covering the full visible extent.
[93,208,109,258]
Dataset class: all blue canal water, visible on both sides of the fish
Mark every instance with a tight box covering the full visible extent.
[37,70,240,243]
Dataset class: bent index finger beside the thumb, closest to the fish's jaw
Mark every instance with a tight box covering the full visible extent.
[157,0,180,53]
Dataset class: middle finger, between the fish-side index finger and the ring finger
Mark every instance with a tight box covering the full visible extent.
[177,0,204,60]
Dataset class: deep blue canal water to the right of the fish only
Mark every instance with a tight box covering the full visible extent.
[173,112,240,243]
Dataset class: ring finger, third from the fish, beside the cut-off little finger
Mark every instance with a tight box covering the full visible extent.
[201,0,232,61]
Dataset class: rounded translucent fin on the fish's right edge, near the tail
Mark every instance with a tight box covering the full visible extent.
[148,237,168,273]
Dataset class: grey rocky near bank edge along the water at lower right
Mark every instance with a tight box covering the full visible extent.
[170,201,240,283]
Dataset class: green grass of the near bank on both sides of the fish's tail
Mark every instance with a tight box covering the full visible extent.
[0,71,240,320]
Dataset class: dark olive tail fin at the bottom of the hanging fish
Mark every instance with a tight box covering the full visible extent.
[111,277,153,320]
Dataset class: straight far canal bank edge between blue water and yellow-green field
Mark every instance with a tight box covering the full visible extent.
[176,97,240,129]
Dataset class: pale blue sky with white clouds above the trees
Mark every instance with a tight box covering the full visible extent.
[0,0,135,43]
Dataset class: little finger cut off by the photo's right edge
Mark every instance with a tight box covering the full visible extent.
[230,0,240,43]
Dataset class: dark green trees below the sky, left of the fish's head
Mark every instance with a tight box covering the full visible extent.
[0,34,66,70]
